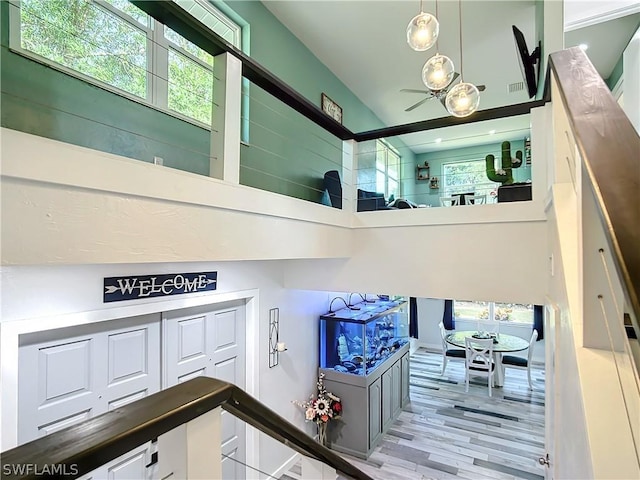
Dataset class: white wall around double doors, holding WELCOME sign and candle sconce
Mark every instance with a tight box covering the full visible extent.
[0,261,333,473]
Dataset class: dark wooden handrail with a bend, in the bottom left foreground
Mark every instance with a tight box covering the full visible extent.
[0,377,372,480]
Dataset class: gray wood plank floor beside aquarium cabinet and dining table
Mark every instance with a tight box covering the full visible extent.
[281,349,545,480]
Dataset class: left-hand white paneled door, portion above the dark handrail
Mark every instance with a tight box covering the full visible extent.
[18,315,160,444]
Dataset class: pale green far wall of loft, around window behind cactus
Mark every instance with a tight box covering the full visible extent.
[405,139,531,207]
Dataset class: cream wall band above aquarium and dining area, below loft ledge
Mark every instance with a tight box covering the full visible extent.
[284,217,549,304]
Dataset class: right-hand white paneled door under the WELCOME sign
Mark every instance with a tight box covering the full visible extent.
[159,301,246,480]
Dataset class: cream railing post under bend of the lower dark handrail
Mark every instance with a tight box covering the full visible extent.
[157,407,222,480]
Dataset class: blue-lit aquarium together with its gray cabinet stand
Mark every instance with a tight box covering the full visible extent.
[320,299,409,459]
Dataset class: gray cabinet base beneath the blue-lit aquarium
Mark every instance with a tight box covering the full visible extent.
[320,344,409,458]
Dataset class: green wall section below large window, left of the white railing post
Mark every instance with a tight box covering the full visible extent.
[0,2,209,175]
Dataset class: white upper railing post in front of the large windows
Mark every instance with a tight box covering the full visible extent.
[209,53,242,184]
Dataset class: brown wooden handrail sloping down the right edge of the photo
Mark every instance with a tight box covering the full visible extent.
[549,47,640,319]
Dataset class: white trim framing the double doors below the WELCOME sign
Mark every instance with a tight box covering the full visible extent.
[0,289,260,458]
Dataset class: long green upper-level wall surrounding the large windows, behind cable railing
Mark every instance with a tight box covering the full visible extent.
[0,1,412,201]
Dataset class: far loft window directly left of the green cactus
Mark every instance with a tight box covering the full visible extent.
[441,160,497,201]
